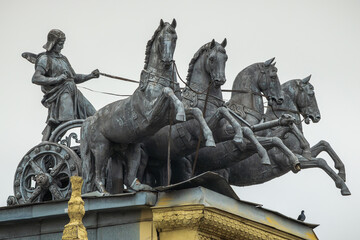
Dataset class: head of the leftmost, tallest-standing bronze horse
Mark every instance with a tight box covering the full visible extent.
[144,19,177,69]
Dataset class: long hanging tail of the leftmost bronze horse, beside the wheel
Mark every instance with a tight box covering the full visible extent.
[80,117,95,193]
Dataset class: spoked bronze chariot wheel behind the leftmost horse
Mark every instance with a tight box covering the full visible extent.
[8,142,81,205]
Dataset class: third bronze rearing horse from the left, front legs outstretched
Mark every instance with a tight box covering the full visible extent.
[174,58,300,181]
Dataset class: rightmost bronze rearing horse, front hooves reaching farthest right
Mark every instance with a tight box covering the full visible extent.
[228,76,351,196]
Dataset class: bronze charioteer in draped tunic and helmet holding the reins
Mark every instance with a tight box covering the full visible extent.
[30,29,99,141]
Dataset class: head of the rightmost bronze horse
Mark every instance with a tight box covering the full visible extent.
[295,75,321,124]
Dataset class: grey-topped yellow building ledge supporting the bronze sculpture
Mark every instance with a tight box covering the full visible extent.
[0,172,317,240]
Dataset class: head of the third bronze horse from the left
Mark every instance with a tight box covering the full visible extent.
[257,58,284,105]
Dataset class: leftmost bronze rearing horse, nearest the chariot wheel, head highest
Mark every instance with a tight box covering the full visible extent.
[80,19,213,194]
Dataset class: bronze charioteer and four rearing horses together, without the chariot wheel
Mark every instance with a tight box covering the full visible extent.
[15,19,350,205]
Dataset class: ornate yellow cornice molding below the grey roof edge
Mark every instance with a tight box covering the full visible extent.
[152,205,303,240]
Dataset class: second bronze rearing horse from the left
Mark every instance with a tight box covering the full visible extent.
[138,39,243,186]
